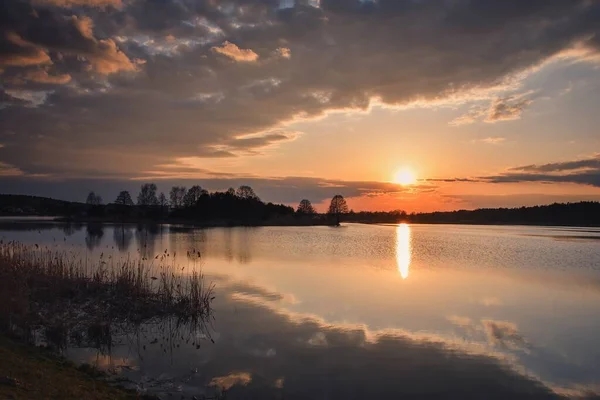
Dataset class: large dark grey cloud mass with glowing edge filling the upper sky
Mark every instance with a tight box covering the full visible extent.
[0,0,600,181]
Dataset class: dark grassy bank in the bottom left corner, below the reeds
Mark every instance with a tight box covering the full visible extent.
[0,335,152,400]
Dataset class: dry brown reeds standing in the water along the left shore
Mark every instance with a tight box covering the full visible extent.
[0,241,214,336]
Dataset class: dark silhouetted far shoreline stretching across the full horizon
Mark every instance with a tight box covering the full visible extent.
[0,193,600,227]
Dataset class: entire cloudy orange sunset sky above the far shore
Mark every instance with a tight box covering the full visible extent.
[0,0,600,212]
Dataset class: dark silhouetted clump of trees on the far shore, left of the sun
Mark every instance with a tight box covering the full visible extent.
[86,183,349,225]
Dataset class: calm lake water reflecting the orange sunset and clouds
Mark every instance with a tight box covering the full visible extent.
[0,219,600,399]
